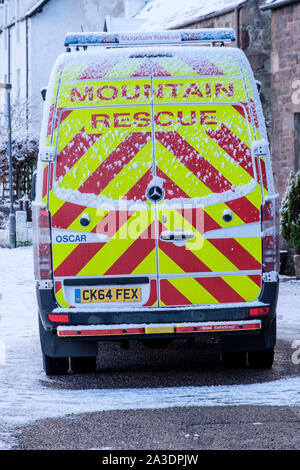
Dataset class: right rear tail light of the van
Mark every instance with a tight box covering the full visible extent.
[261,195,279,272]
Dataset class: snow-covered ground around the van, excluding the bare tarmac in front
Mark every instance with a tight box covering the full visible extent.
[0,247,300,449]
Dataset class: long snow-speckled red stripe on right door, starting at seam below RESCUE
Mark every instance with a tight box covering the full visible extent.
[155,131,233,193]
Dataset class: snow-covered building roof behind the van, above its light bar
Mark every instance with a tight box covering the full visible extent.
[135,0,246,31]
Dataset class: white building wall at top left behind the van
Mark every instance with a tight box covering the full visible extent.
[0,0,125,135]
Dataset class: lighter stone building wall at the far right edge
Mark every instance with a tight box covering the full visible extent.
[271,3,300,204]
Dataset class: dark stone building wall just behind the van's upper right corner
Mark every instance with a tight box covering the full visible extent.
[186,0,272,138]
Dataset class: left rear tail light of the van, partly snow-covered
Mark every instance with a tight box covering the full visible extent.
[32,204,52,280]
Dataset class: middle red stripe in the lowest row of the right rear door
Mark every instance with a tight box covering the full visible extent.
[195,277,245,303]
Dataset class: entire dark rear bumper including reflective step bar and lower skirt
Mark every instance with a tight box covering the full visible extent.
[37,281,279,357]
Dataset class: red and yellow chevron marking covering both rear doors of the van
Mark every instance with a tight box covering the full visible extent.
[43,52,267,306]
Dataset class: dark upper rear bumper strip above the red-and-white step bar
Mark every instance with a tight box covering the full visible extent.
[36,281,279,333]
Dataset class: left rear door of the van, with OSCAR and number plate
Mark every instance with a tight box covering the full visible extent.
[49,60,157,308]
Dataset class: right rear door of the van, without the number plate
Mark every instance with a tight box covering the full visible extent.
[153,48,262,306]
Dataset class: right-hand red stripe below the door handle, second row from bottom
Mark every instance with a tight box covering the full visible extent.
[209,238,261,271]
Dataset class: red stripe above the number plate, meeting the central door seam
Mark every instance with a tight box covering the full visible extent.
[105,222,155,275]
